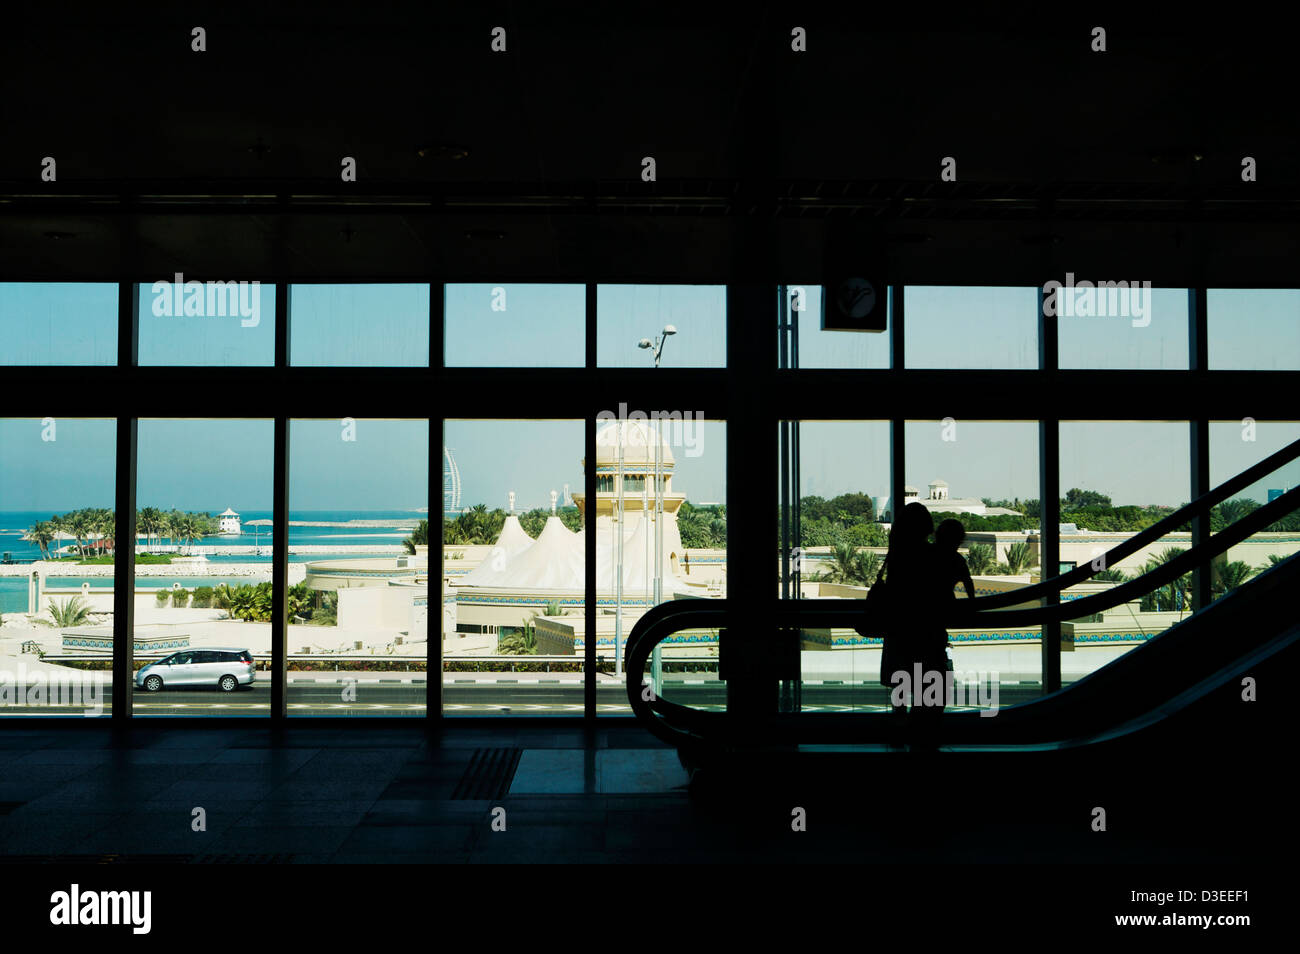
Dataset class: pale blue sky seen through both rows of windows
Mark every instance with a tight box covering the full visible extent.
[0,282,1300,509]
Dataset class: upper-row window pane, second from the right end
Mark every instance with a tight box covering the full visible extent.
[1057,289,1190,370]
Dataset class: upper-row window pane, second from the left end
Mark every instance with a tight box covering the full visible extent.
[137,276,276,367]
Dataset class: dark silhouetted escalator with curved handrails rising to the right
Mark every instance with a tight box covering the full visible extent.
[627,441,1300,763]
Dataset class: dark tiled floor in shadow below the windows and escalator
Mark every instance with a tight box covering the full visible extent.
[0,721,1284,863]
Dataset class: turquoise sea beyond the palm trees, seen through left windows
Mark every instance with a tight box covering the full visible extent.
[0,507,426,613]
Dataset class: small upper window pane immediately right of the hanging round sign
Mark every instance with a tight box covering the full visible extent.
[904,285,1039,368]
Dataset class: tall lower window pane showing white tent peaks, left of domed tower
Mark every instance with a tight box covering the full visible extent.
[442,421,587,715]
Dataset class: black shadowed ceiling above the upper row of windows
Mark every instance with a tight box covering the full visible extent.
[0,0,1300,285]
